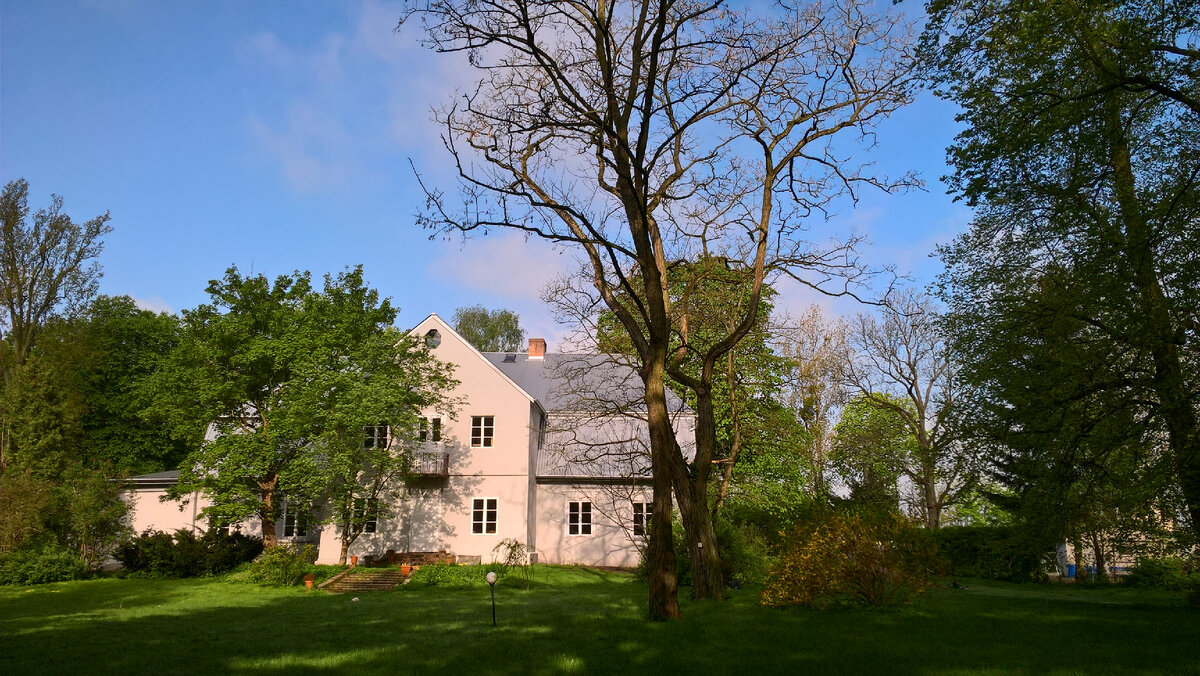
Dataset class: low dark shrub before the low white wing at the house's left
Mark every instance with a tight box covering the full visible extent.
[114,530,263,578]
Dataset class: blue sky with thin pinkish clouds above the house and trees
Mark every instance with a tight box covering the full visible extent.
[0,0,968,349]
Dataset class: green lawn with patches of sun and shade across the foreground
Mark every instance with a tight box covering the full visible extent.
[0,568,1200,676]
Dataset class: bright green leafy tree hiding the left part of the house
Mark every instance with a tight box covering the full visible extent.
[151,268,446,545]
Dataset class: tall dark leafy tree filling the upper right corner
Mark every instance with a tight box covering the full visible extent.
[925,0,1200,540]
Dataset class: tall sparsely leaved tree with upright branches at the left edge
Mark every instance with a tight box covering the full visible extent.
[0,179,112,472]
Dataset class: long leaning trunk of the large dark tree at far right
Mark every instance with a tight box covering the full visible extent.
[1105,92,1200,537]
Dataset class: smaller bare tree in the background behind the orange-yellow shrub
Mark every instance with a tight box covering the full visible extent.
[845,291,976,528]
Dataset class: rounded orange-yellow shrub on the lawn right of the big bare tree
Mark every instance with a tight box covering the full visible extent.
[762,515,937,606]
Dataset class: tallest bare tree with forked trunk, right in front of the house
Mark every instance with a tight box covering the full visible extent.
[402,0,913,618]
